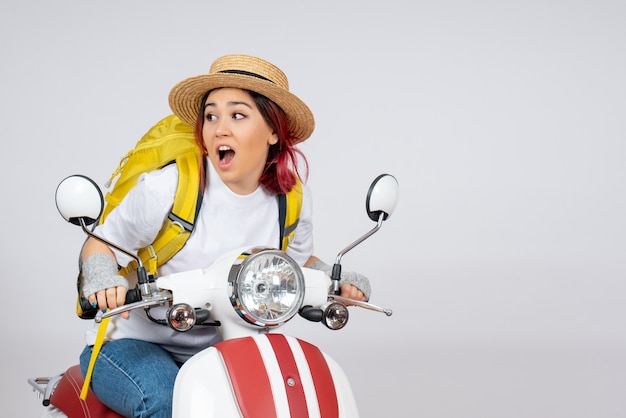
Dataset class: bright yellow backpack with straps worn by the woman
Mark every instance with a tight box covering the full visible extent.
[76,115,302,319]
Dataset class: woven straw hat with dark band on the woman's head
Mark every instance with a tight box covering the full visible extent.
[169,54,315,141]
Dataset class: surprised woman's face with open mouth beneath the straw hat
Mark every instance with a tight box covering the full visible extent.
[202,88,278,194]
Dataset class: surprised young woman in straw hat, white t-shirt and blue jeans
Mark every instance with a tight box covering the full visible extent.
[80,55,370,417]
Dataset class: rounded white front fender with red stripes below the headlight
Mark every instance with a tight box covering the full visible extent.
[173,334,358,418]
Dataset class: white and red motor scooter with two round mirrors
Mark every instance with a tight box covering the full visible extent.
[28,174,398,418]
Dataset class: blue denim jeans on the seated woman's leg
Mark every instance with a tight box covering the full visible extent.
[80,339,179,418]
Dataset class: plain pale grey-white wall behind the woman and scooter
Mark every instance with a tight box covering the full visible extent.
[0,0,626,418]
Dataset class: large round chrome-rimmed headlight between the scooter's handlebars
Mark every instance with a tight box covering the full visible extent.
[228,248,305,327]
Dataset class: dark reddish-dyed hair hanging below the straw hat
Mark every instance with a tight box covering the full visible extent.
[196,90,309,194]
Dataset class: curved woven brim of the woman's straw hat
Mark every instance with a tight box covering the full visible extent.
[169,74,315,142]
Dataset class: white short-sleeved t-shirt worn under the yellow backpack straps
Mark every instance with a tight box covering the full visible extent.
[86,162,313,361]
